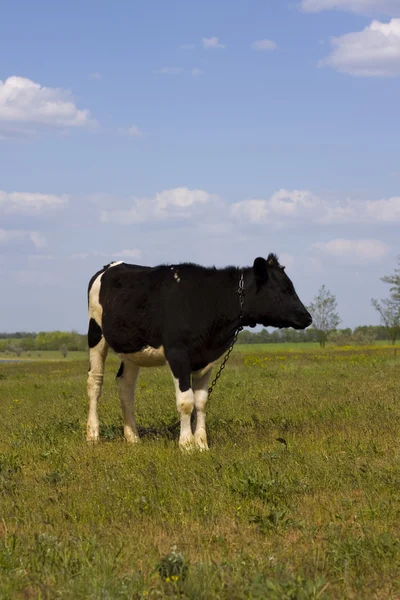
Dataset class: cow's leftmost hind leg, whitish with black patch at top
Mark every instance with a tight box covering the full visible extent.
[87,319,108,442]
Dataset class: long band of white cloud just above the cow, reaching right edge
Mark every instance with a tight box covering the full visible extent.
[88,187,400,229]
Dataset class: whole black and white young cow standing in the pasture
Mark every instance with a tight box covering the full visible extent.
[87,254,312,449]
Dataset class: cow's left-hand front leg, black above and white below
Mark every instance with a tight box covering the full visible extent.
[167,350,194,449]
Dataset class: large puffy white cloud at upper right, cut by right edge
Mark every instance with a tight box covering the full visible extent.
[319,19,400,77]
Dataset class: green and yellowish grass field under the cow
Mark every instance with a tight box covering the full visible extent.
[0,345,400,600]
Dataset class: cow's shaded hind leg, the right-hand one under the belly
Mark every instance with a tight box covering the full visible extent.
[117,361,139,444]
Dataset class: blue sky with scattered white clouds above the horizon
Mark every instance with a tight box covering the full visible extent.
[0,0,400,331]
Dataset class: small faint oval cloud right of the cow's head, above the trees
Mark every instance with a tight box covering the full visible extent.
[312,238,389,264]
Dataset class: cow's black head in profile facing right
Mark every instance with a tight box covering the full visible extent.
[245,254,312,329]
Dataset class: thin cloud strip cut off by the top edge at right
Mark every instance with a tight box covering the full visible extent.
[301,0,400,16]
